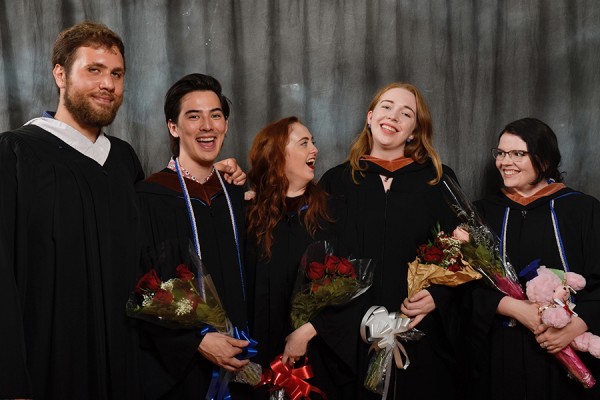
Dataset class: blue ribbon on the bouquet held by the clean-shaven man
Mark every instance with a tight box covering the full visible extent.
[200,325,258,400]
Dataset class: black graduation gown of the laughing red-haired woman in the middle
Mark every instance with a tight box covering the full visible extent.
[246,199,356,400]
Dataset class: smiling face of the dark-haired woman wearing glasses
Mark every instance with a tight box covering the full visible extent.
[496,132,548,197]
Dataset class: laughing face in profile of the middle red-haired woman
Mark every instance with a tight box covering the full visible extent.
[285,122,319,197]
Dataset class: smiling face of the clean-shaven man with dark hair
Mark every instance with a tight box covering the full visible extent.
[168,91,227,176]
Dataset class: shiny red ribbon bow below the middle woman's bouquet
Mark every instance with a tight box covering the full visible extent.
[256,355,327,400]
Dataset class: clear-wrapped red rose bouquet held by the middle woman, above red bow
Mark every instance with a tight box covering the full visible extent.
[290,241,374,329]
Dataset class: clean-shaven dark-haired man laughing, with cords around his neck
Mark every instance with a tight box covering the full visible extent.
[136,73,251,400]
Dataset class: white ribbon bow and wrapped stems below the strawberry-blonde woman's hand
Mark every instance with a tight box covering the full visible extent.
[360,306,423,398]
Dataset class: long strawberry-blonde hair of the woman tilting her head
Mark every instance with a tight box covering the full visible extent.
[346,82,442,185]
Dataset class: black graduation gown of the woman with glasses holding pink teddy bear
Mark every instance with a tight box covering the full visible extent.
[469,188,600,400]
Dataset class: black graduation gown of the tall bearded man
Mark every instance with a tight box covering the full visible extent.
[0,125,143,400]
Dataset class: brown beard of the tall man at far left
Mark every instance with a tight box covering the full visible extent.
[64,82,123,128]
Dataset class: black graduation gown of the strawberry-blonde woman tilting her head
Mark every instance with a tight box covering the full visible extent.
[320,161,458,399]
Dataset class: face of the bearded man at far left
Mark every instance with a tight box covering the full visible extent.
[53,47,125,139]
